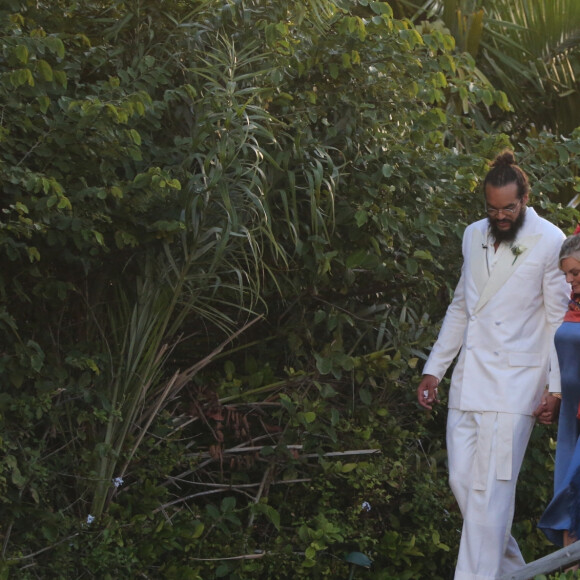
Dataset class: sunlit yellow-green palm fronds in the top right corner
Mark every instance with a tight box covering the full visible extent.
[395,0,580,136]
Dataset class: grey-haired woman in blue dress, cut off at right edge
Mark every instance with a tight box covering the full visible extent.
[538,232,580,546]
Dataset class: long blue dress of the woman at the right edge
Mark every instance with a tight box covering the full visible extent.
[538,322,580,546]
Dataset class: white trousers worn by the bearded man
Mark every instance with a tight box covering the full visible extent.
[447,409,535,580]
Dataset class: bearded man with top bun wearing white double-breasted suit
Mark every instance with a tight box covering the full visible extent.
[417,151,569,580]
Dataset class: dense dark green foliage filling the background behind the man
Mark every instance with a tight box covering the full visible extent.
[0,0,580,579]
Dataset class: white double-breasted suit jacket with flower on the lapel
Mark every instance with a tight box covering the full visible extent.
[423,207,570,415]
